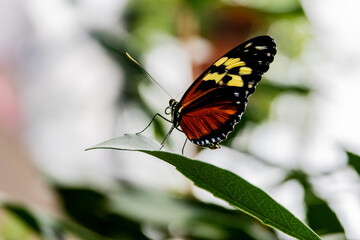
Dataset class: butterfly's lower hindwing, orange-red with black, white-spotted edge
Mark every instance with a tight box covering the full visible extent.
[180,87,247,147]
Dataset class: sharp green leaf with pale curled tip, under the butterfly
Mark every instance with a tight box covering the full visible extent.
[86,134,320,240]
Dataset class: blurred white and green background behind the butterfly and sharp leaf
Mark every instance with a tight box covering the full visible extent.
[0,0,360,240]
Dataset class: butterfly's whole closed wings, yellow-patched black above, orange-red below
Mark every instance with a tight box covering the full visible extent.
[178,36,276,148]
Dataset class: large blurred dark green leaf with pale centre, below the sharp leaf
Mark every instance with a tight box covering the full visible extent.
[58,184,274,239]
